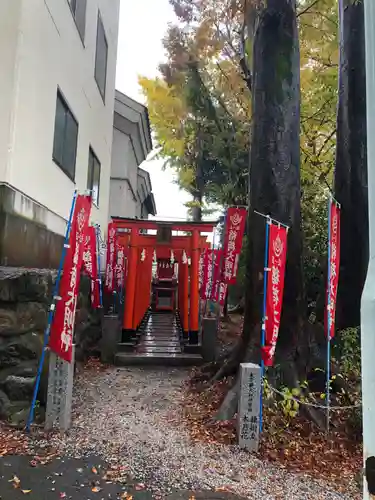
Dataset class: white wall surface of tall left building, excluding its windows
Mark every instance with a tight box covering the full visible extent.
[0,0,119,234]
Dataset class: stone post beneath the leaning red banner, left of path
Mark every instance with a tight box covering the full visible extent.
[45,345,75,432]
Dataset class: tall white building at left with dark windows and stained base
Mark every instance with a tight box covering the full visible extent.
[0,0,120,267]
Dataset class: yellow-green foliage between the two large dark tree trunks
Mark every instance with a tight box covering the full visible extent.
[299,0,339,307]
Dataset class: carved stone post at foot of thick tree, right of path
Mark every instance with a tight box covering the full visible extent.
[237,363,261,451]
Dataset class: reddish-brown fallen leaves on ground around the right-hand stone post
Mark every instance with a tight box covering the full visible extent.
[183,321,363,494]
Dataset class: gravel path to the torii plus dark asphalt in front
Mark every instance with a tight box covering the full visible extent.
[0,368,359,500]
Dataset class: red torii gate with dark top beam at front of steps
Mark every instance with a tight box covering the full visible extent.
[112,217,217,344]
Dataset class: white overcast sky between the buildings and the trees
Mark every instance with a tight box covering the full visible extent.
[116,0,189,219]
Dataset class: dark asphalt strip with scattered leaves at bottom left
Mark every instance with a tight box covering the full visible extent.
[0,456,244,500]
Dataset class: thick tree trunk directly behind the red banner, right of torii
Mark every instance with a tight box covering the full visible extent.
[217,0,308,385]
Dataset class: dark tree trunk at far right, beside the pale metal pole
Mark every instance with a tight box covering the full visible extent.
[334,0,369,329]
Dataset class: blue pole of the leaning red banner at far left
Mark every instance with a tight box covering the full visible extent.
[26,190,77,432]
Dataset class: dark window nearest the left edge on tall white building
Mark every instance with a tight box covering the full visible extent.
[53,91,78,181]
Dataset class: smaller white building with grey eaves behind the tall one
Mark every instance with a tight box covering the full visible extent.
[109,90,156,219]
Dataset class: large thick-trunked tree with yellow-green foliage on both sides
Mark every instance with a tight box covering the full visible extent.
[142,0,346,392]
